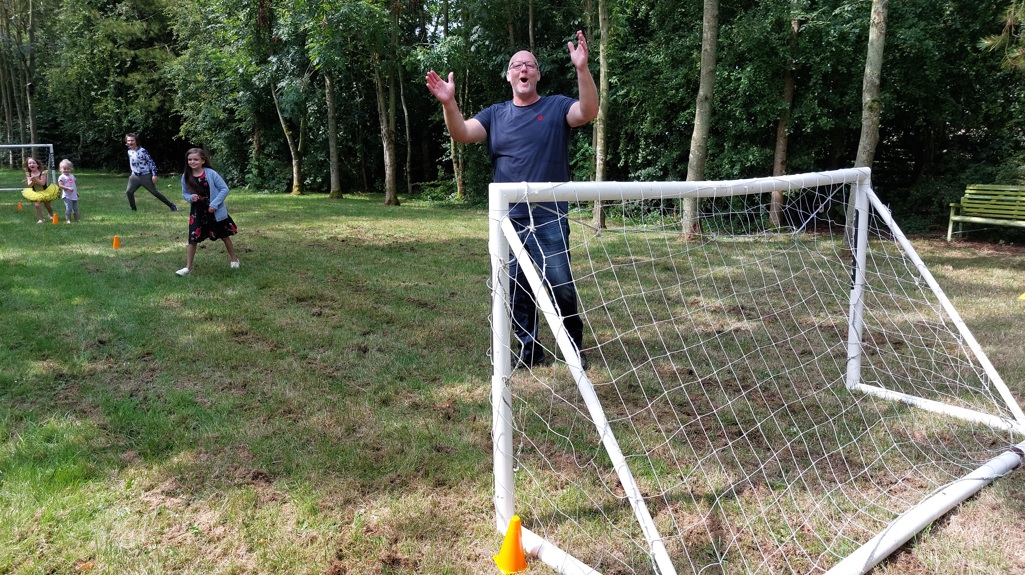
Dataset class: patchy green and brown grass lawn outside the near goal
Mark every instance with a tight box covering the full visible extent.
[0,172,1025,575]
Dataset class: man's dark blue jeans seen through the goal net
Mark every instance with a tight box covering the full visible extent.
[509,216,583,365]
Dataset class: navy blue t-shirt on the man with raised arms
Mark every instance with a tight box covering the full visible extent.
[475,95,576,222]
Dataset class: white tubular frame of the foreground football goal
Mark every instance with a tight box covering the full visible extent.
[489,168,1025,575]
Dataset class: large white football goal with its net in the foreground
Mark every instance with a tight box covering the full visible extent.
[489,168,1025,575]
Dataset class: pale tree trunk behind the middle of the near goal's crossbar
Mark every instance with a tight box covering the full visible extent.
[681,0,719,239]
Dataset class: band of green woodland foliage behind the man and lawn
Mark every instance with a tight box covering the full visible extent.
[6,0,1025,221]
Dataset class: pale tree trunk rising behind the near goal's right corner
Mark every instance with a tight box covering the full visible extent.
[847,0,889,239]
